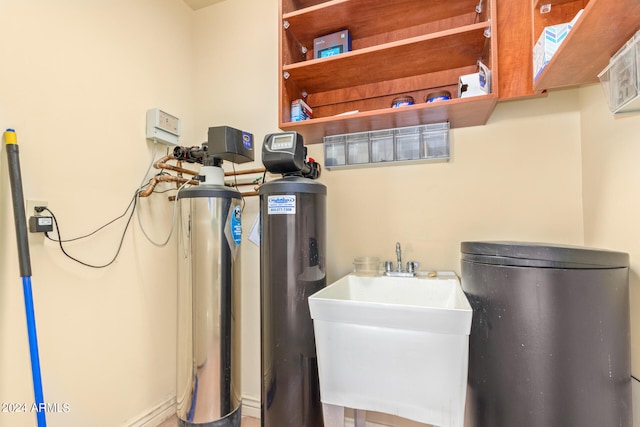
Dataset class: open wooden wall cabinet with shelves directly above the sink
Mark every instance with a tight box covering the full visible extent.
[279,0,498,143]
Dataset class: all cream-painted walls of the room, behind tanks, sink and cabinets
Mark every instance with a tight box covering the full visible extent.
[0,0,640,427]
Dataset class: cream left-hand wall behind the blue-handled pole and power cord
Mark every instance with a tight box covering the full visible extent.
[0,0,194,427]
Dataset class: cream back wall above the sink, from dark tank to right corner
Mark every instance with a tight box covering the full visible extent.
[310,91,582,280]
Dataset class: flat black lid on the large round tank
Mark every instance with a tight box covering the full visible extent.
[460,242,629,269]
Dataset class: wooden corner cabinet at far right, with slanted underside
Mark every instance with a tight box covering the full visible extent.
[496,0,640,100]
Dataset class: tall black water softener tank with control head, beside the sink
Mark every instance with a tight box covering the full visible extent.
[260,133,327,427]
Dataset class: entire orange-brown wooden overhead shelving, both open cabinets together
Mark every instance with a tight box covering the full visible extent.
[279,0,640,143]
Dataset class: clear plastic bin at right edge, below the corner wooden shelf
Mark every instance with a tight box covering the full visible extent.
[598,31,640,114]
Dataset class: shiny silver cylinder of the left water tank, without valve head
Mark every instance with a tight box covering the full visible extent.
[176,185,241,427]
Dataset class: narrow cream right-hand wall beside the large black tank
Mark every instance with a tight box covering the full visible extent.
[580,85,640,375]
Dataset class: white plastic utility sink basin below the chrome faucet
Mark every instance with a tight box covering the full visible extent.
[309,272,472,427]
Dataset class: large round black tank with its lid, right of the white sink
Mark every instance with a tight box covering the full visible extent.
[461,242,632,427]
